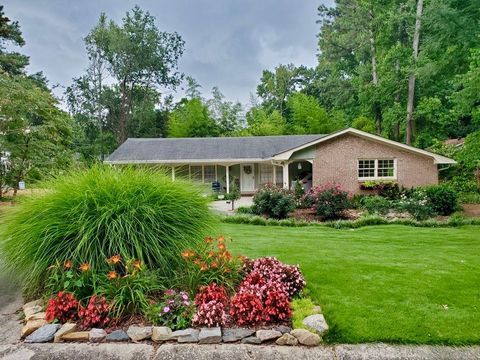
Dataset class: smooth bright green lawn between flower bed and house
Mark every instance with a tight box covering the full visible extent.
[221,224,480,344]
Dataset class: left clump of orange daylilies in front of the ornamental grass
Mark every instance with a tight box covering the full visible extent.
[96,255,160,318]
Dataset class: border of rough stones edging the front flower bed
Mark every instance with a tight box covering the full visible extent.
[21,300,328,347]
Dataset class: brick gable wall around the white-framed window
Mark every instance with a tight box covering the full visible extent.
[313,134,438,193]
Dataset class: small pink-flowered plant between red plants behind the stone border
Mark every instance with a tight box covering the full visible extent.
[148,289,193,330]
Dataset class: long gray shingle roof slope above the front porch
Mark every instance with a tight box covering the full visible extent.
[106,135,325,163]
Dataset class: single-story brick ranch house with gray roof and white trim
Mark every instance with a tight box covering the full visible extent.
[105,128,455,194]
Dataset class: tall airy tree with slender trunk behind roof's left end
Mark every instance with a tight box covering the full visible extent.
[89,6,184,143]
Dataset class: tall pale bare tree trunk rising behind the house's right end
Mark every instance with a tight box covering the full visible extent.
[405,0,423,145]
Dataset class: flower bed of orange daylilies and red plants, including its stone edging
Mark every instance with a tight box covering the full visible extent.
[17,236,328,346]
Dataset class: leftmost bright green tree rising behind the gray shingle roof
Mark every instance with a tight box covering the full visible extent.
[168,98,218,137]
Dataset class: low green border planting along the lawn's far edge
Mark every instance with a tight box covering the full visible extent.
[221,214,480,229]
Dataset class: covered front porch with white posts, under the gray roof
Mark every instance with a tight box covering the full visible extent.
[169,160,312,195]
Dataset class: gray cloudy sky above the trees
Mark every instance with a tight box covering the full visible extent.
[3,0,332,103]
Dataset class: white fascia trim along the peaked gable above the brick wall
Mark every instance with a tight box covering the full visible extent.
[273,128,457,164]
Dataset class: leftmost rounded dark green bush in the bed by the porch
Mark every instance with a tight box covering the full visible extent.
[252,184,295,219]
